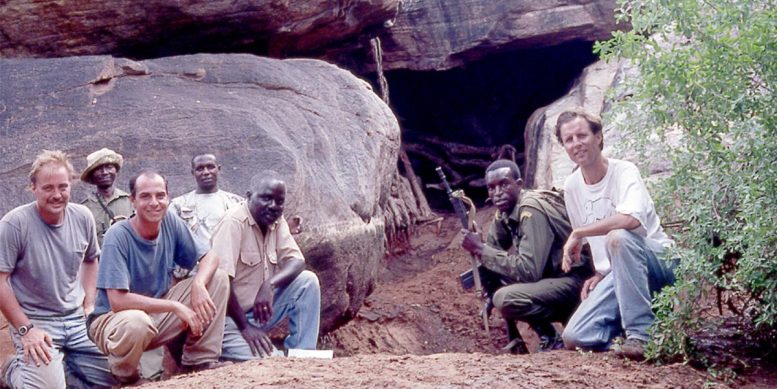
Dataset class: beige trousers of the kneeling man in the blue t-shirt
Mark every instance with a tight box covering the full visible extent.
[89,270,229,382]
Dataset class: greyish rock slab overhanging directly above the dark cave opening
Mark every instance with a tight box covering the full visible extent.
[366,0,616,70]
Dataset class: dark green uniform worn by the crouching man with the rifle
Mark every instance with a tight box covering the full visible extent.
[480,190,593,324]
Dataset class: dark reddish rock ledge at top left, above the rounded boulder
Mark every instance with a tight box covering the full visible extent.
[0,0,400,58]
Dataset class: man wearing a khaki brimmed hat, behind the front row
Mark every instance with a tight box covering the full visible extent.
[81,148,133,246]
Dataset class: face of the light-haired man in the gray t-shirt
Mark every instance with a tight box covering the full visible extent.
[30,163,70,224]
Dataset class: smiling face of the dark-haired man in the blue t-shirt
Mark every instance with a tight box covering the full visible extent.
[130,174,170,224]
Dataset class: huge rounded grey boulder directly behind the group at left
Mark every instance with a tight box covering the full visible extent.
[0,54,400,331]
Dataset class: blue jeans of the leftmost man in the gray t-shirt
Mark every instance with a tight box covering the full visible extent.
[4,310,119,389]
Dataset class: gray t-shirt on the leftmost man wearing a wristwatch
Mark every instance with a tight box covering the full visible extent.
[0,202,100,318]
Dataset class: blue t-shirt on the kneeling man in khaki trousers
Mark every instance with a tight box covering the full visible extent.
[93,209,208,316]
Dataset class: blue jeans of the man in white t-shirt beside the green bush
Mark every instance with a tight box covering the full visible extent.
[561,230,675,350]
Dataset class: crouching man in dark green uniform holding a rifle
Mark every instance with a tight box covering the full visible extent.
[461,160,593,353]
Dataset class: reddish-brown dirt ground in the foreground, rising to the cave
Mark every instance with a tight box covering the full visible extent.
[0,211,777,388]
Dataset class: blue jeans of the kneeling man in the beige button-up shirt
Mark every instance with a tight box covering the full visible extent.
[221,270,321,361]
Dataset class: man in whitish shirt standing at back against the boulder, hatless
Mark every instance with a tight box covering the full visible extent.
[172,154,244,247]
